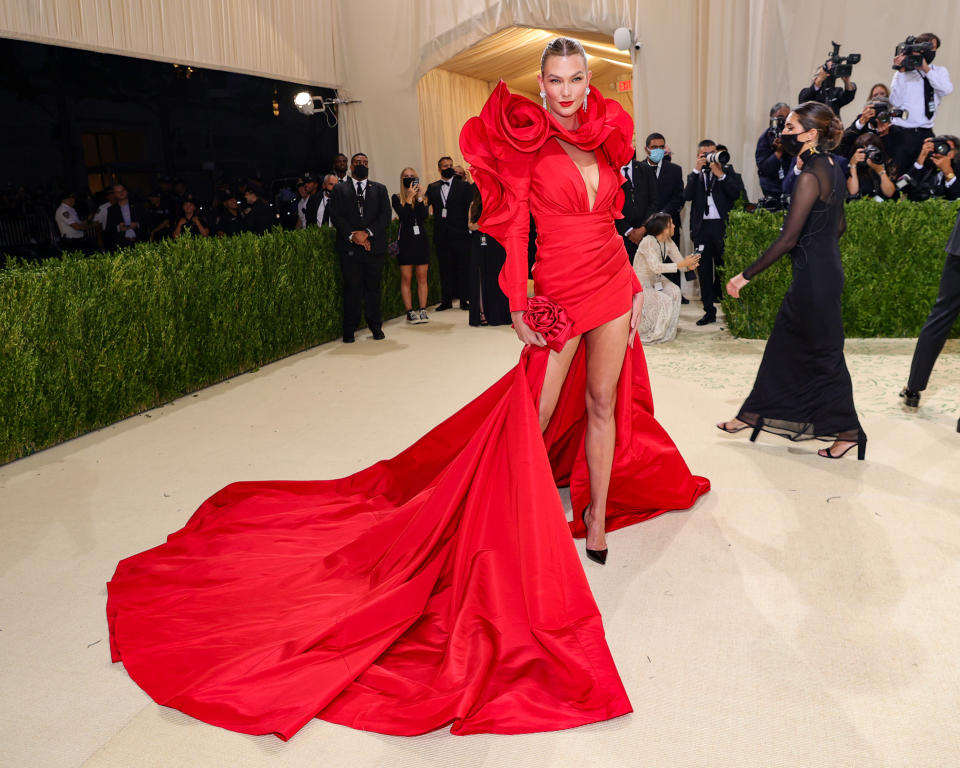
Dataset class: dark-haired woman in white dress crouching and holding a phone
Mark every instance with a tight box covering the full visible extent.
[633,212,700,344]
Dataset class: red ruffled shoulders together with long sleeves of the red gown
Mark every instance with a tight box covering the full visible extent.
[460,80,642,312]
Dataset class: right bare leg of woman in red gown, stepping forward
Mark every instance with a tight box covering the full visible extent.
[584,312,630,549]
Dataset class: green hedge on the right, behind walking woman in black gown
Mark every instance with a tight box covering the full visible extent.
[722,200,960,339]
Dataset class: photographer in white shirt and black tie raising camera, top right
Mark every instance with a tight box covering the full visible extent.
[890,32,953,166]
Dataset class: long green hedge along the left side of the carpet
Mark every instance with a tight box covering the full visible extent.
[0,222,439,463]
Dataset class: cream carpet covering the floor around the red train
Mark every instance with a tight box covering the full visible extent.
[0,306,960,768]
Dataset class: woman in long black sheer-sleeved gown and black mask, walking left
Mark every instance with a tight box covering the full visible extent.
[717,102,867,459]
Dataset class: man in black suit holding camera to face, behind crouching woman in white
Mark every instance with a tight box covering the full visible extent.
[683,139,745,325]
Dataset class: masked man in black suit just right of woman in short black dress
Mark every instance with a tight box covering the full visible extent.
[427,157,473,312]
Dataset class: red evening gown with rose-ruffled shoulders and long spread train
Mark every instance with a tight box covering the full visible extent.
[107,83,709,739]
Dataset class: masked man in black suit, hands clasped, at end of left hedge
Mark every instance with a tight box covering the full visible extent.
[331,152,392,344]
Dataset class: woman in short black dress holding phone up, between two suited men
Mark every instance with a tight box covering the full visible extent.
[390,168,430,325]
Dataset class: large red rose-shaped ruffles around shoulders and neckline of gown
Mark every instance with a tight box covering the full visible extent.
[460,80,633,240]
